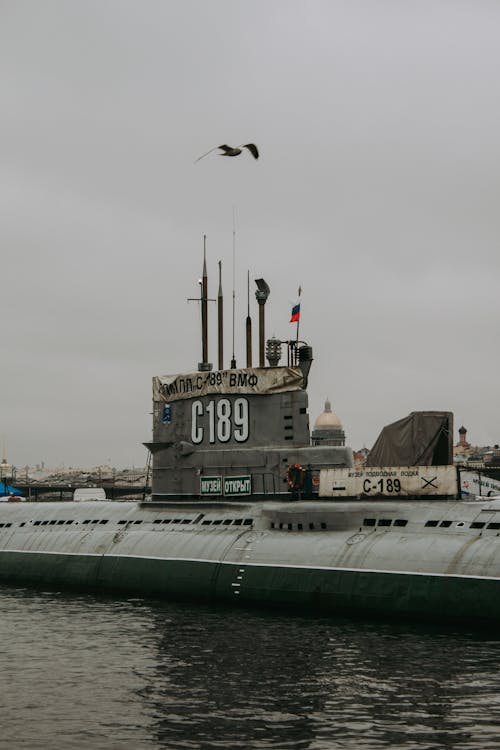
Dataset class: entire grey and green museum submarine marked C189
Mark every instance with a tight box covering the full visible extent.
[0,258,500,625]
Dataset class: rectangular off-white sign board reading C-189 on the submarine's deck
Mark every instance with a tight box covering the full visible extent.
[319,466,457,497]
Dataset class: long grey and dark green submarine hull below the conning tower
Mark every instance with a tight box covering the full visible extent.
[0,501,500,623]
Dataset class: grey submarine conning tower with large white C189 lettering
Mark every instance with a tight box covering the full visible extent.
[145,258,353,501]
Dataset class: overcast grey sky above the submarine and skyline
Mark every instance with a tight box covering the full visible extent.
[0,0,500,466]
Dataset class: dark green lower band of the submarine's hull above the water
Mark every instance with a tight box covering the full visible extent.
[0,552,500,623]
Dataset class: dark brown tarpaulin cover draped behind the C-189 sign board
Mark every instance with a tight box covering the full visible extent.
[366,411,453,466]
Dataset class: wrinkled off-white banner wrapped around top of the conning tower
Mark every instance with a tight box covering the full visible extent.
[153,367,304,403]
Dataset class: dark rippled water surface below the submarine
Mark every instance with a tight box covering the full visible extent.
[0,587,500,750]
